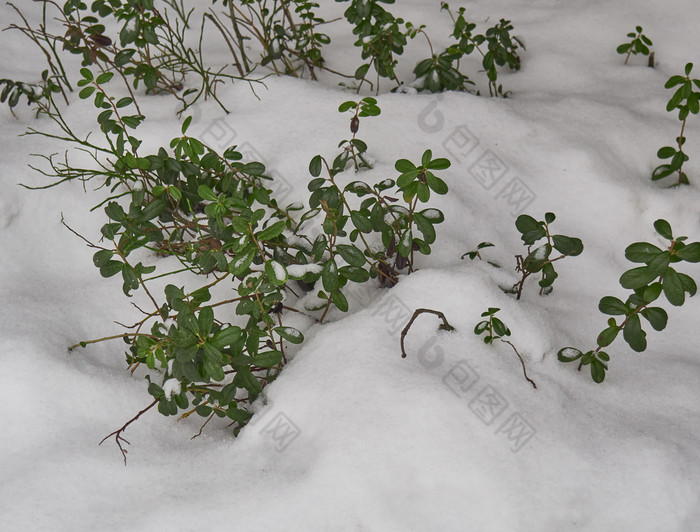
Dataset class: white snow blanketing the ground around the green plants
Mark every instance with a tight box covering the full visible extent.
[0,0,700,532]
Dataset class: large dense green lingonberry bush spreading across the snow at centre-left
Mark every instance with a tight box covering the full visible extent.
[17,52,450,457]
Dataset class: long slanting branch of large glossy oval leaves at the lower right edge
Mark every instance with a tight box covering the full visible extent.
[557,219,700,383]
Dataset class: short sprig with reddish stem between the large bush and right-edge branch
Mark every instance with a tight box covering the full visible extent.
[510,212,583,299]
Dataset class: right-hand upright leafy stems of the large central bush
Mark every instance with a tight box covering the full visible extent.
[299,150,450,294]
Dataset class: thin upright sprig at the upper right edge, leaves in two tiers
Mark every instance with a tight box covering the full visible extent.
[651,63,700,185]
